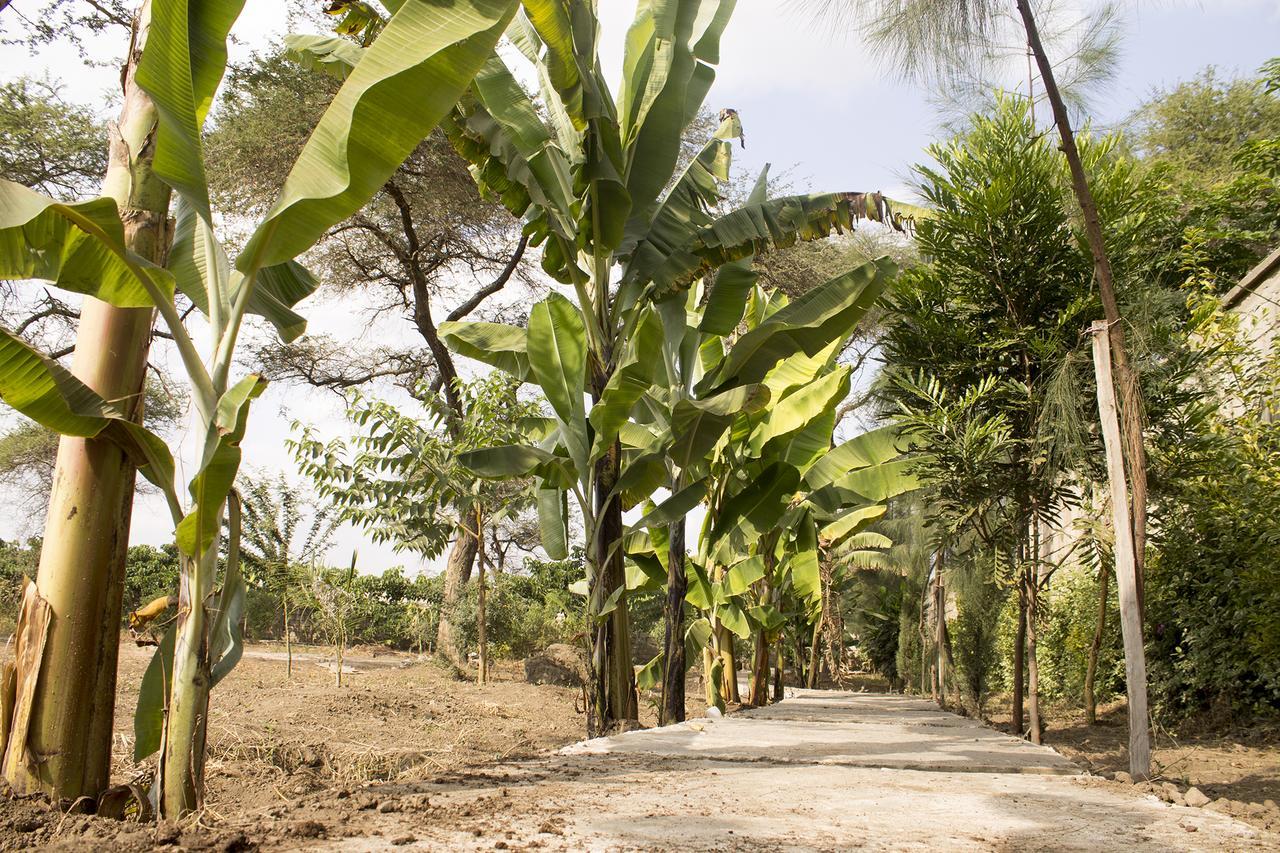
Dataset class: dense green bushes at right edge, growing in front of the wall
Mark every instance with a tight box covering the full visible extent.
[1147,286,1280,719]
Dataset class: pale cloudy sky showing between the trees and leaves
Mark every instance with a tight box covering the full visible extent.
[0,0,1280,573]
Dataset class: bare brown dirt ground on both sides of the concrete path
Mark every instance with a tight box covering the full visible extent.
[0,646,1280,852]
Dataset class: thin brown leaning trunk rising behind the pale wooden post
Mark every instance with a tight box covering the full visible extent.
[1018,0,1147,596]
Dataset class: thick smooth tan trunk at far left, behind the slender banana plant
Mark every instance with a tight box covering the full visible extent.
[4,4,172,799]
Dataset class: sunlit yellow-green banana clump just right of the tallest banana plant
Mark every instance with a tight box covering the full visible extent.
[630,275,910,703]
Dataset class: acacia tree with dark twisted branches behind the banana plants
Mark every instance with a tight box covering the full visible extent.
[209,46,527,663]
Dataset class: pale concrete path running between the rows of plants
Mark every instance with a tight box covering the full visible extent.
[330,690,1280,852]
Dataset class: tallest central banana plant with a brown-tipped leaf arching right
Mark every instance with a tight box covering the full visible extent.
[330,0,911,731]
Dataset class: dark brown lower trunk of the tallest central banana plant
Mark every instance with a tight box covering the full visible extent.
[588,442,640,735]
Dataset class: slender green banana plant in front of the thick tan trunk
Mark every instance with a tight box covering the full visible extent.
[0,0,516,817]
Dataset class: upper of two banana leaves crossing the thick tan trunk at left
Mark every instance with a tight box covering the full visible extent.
[0,179,174,307]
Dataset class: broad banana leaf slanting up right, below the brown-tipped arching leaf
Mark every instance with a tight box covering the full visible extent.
[698,257,897,396]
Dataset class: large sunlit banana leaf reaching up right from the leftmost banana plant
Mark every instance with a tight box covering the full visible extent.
[237,0,516,274]
